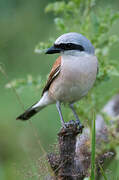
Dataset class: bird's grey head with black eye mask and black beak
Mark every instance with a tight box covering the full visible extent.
[46,32,95,54]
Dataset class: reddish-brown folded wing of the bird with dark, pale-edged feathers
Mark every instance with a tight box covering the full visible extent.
[42,56,61,95]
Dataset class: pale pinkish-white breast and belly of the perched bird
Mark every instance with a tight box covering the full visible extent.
[50,52,98,103]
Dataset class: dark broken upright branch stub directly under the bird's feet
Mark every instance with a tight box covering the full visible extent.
[48,121,84,180]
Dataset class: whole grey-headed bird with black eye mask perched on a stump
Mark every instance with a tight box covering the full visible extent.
[16,32,98,127]
